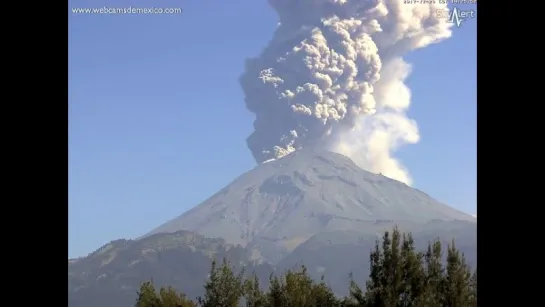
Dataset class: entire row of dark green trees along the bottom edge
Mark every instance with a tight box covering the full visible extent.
[135,228,477,307]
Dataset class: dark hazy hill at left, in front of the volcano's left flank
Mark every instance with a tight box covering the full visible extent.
[68,231,273,307]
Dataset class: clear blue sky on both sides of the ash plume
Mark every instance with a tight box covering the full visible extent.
[68,0,477,258]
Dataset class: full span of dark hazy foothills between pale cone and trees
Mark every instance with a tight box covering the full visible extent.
[68,220,477,307]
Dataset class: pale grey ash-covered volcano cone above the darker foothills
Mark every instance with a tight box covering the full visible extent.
[143,148,476,261]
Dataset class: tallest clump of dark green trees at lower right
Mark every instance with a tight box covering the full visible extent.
[346,227,477,307]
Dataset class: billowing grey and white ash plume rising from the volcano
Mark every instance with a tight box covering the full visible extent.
[240,0,452,184]
